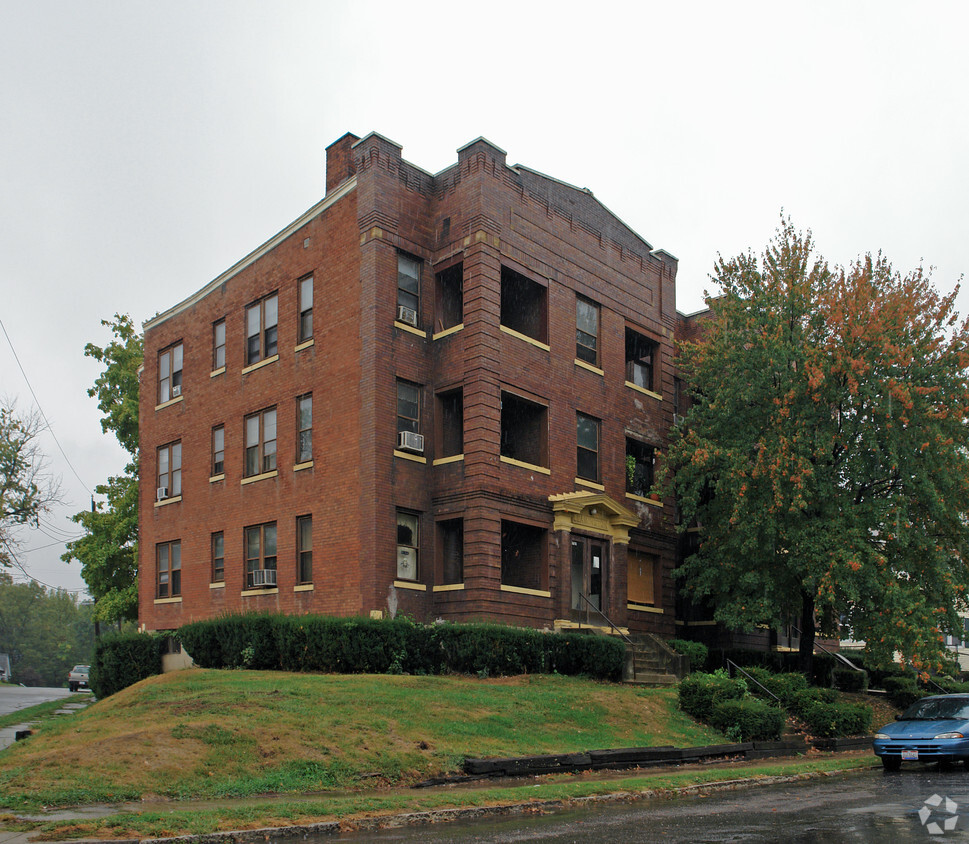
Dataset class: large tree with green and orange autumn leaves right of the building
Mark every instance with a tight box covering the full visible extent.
[665,220,969,671]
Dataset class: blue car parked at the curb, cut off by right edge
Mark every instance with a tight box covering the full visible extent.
[872,694,969,771]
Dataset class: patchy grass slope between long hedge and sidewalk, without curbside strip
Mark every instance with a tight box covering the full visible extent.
[0,670,722,811]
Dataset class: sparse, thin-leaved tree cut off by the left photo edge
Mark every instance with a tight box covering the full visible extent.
[0,402,58,566]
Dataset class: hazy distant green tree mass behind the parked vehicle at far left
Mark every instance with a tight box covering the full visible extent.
[0,572,94,686]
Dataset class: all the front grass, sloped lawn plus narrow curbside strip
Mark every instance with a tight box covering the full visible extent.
[0,669,874,838]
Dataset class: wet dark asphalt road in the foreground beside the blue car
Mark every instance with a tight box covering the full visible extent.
[328,766,969,844]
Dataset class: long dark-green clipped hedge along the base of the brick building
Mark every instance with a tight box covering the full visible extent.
[178,614,625,680]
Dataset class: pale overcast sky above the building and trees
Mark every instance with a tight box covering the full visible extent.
[0,0,969,589]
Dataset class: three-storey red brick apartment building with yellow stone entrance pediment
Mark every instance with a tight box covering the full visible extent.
[139,129,677,637]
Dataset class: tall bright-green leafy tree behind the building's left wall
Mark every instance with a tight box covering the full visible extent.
[62,314,144,624]
